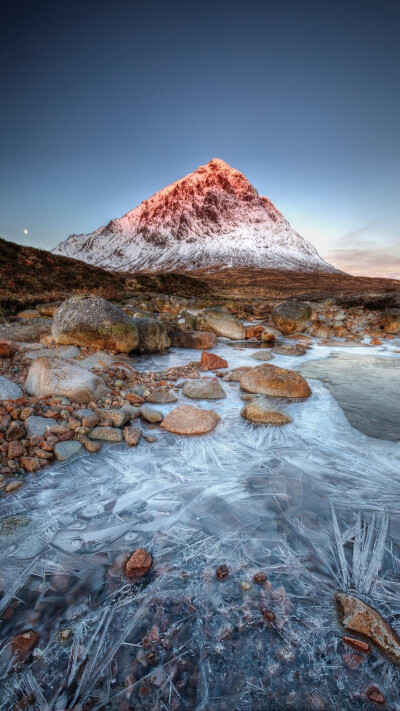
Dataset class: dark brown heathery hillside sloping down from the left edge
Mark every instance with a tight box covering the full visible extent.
[0,238,210,315]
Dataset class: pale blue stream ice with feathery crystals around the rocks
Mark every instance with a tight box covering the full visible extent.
[0,345,400,711]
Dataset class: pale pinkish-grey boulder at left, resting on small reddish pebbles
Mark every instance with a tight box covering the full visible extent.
[25,358,110,404]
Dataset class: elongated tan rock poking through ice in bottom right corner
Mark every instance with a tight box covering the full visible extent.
[335,593,400,664]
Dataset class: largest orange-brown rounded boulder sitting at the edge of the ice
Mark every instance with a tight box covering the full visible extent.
[240,363,311,398]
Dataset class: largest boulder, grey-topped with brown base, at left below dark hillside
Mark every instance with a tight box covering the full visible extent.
[52,295,139,353]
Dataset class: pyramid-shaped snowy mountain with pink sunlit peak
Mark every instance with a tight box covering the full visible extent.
[53,158,336,272]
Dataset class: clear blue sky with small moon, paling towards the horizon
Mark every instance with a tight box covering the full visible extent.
[0,0,400,276]
